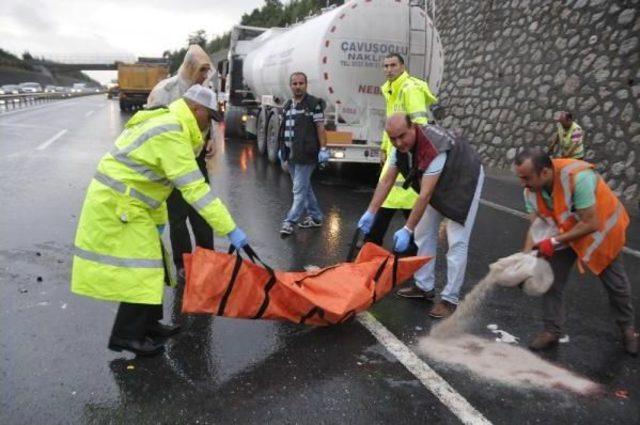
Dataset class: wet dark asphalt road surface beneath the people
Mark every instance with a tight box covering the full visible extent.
[0,96,640,424]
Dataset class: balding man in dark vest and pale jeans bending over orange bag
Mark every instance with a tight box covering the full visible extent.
[358,113,484,318]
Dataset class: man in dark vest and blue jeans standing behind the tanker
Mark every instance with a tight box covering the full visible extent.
[279,72,329,237]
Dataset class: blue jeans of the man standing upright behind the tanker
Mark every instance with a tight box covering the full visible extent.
[284,163,323,224]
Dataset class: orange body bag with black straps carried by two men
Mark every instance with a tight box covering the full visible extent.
[182,238,430,326]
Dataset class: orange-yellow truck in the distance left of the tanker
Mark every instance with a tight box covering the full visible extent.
[118,60,169,111]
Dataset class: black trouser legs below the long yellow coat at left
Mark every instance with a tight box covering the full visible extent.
[111,302,162,340]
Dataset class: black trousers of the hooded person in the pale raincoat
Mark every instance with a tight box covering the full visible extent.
[167,149,213,269]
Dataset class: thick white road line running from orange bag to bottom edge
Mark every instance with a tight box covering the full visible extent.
[357,312,491,425]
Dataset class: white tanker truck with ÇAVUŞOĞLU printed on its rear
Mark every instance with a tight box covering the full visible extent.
[218,0,444,163]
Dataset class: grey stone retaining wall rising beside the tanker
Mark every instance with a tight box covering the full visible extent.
[436,0,640,201]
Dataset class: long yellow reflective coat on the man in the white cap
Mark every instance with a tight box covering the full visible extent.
[71,100,236,304]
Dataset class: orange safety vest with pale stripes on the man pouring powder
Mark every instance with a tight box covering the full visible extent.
[527,159,629,275]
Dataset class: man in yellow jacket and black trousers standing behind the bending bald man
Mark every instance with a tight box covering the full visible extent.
[366,53,438,256]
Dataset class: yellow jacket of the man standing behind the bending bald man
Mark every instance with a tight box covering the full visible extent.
[380,72,438,209]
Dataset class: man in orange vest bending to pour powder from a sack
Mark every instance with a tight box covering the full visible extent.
[515,148,638,355]
